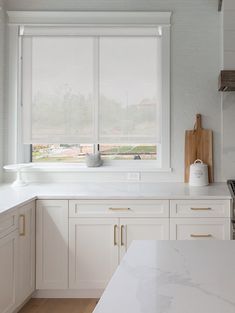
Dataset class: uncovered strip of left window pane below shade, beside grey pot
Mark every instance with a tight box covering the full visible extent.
[32,144,93,163]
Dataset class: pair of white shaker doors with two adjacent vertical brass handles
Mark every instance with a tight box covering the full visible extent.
[69,218,169,290]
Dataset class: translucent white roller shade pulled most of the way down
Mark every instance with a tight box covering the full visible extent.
[21,27,162,144]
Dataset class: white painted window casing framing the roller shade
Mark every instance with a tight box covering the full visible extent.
[7,11,171,172]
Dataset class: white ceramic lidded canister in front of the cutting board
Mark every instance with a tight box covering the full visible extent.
[189,159,209,187]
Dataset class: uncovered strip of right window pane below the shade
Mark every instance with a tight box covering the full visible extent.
[99,144,157,160]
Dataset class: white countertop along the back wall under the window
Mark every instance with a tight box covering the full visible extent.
[0,182,231,213]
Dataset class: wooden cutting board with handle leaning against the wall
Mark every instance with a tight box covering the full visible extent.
[184,114,214,183]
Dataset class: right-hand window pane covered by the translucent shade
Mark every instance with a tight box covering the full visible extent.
[99,37,161,143]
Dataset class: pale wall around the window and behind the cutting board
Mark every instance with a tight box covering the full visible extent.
[6,0,222,181]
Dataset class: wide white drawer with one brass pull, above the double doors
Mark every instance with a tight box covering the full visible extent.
[69,200,169,217]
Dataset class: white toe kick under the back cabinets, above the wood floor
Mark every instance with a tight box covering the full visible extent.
[32,289,104,299]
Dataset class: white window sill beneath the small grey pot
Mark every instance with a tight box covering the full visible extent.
[6,163,172,173]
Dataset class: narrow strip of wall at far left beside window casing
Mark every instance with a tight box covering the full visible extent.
[0,0,5,182]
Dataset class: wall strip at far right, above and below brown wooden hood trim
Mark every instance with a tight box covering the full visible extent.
[223,0,235,179]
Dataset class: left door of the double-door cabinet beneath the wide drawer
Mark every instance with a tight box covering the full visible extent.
[69,218,119,290]
